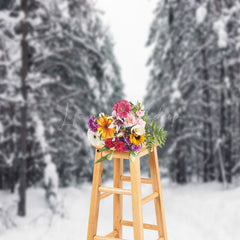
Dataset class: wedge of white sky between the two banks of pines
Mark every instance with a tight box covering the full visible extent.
[96,0,157,102]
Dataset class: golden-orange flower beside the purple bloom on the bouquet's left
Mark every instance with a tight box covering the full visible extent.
[97,115,115,138]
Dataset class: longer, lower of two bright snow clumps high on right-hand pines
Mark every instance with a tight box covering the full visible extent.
[213,19,228,48]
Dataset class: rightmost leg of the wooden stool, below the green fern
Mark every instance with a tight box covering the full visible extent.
[149,147,167,240]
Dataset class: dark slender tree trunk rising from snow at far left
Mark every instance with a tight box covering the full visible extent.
[18,0,28,216]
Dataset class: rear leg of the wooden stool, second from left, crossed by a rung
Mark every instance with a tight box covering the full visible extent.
[113,158,123,238]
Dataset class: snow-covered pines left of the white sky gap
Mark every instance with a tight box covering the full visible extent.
[0,0,123,215]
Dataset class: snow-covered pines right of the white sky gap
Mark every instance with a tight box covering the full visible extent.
[145,0,239,183]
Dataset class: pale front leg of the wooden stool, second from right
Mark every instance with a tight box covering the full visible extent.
[130,157,144,240]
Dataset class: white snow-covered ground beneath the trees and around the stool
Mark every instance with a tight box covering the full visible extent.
[0,177,240,240]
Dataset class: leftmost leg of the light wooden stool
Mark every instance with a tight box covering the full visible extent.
[87,150,103,240]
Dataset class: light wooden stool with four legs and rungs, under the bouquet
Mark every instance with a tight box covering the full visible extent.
[87,145,167,240]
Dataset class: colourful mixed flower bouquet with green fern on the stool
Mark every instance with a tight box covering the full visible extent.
[87,100,166,163]
